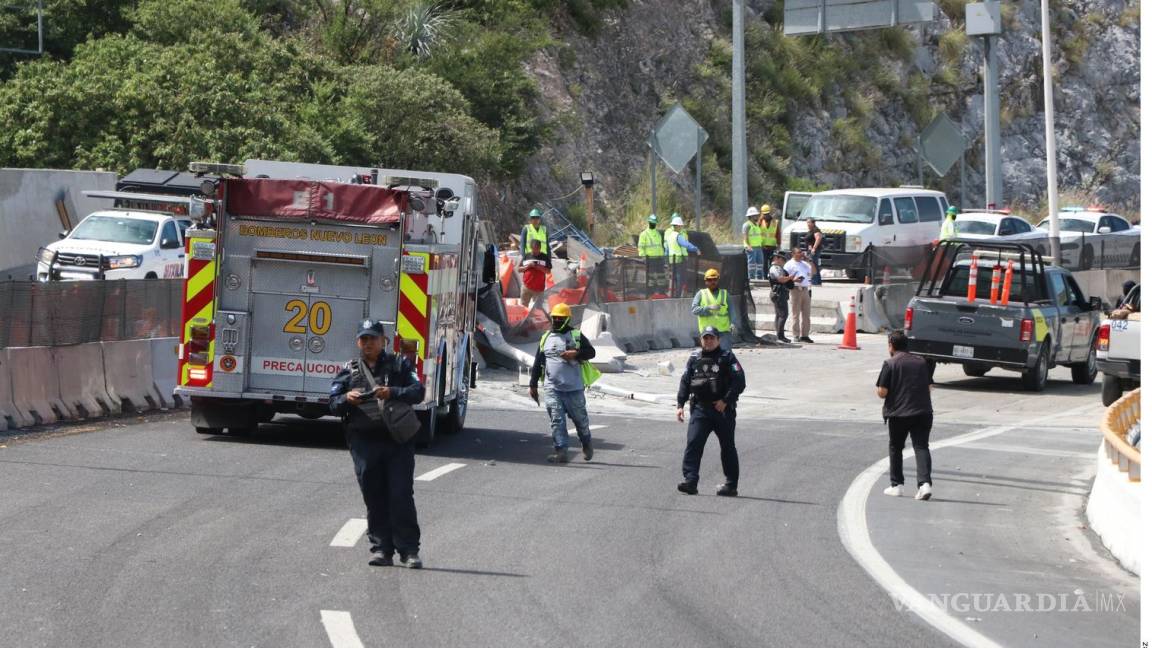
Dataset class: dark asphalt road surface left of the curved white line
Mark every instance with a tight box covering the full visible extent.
[0,373,1133,648]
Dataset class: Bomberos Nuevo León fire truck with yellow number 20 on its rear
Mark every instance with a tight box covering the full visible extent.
[176,160,478,444]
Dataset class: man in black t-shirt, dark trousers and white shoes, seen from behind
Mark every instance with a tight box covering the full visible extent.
[876,331,932,499]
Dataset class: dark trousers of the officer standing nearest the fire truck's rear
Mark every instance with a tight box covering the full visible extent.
[344,425,420,555]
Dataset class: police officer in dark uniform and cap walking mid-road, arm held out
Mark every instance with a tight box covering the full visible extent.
[676,326,744,497]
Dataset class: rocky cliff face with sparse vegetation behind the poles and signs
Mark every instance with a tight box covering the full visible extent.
[498,0,1139,231]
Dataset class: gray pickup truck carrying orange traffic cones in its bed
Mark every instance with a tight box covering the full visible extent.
[904,239,1101,391]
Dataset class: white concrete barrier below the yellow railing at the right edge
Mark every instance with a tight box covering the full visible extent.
[1085,442,1144,575]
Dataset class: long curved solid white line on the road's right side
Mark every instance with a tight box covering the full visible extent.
[836,404,1099,648]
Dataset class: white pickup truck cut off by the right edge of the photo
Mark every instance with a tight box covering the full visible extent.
[1096,284,1140,405]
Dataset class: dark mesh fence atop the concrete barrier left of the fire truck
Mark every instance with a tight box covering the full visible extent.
[0,279,184,348]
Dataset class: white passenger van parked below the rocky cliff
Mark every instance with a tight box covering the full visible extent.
[781,187,948,276]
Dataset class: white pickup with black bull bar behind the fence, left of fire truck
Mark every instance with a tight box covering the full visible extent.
[36,210,191,281]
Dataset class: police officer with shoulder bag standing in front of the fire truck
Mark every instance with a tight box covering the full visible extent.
[328,319,424,568]
